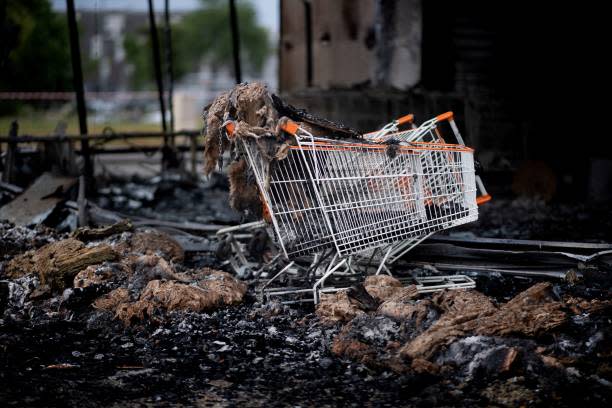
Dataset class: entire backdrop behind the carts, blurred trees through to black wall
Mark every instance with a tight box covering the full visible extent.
[0,0,612,201]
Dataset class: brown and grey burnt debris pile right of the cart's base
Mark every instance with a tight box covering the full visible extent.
[316,276,612,387]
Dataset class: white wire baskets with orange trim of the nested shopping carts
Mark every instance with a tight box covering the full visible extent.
[226,114,490,303]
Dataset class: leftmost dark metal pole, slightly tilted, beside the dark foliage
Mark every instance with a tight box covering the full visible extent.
[66,0,93,182]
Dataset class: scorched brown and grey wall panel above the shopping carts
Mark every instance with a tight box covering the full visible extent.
[280,0,422,92]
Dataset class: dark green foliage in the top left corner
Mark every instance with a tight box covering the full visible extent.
[0,0,72,91]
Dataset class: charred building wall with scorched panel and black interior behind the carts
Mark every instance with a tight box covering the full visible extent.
[280,0,612,202]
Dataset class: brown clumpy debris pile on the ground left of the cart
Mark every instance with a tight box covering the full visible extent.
[1,221,246,324]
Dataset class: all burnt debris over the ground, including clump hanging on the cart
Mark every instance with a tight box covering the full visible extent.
[0,84,612,406]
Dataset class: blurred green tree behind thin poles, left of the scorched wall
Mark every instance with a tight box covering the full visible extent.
[124,0,271,89]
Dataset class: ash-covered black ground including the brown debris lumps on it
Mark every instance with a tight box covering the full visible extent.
[0,179,612,406]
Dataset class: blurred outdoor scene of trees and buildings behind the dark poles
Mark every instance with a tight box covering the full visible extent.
[0,0,279,135]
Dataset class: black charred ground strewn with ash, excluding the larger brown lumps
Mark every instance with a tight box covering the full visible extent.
[0,176,612,406]
